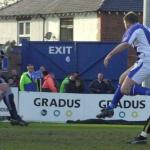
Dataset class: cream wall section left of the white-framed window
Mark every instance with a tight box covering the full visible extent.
[0,20,17,44]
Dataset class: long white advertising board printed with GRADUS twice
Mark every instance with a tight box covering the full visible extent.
[19,92,150,122]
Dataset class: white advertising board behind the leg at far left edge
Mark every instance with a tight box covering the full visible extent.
[0,87,18,116]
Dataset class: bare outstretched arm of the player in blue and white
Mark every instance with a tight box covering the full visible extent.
[104,42,131,67]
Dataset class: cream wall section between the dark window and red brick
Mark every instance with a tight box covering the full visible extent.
[73,13,100,41]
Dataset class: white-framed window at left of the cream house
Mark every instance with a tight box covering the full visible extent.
[18,21,30,44]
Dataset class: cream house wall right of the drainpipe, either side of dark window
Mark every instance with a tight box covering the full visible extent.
[47,13,100,41]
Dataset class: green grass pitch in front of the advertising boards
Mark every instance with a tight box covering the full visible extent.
[0,123,150,150]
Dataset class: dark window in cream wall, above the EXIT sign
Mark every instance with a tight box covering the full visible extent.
[60,18,73,41]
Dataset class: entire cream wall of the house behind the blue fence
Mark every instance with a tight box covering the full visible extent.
[0,13,100,44]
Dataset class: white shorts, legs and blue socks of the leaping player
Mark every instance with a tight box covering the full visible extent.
[96,62,150,118]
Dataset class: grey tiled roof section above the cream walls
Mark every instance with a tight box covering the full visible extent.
[0,0,101,16]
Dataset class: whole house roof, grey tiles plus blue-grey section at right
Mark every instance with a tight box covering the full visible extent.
[0,0,143,16]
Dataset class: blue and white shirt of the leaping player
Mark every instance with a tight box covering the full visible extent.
[122,23,150,62]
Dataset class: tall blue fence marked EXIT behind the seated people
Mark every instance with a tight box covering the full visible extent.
[21,40,128,92]
